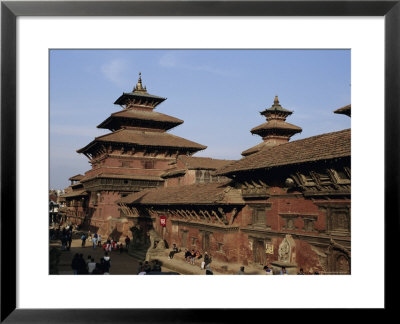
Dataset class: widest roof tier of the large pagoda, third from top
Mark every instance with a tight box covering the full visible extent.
[77,128,207,153]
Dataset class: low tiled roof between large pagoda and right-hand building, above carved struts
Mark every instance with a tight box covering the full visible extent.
[117,183,244,205]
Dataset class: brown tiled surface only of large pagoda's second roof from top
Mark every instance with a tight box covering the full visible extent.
[97,109,183,128]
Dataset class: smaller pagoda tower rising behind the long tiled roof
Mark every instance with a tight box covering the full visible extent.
[242,96,302,156]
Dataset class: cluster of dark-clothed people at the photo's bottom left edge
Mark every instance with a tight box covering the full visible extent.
[71,252,111,275]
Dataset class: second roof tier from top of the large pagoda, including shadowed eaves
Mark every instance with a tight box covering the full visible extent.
[97,109,183,130]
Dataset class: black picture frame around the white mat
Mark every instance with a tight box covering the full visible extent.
[0,0,400,323]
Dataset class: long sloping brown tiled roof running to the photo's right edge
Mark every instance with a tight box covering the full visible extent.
[217,129,351,175]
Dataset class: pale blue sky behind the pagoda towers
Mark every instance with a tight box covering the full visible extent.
[50,50,351,189]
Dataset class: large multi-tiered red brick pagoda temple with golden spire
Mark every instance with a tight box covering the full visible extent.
[65,74,206,235]
